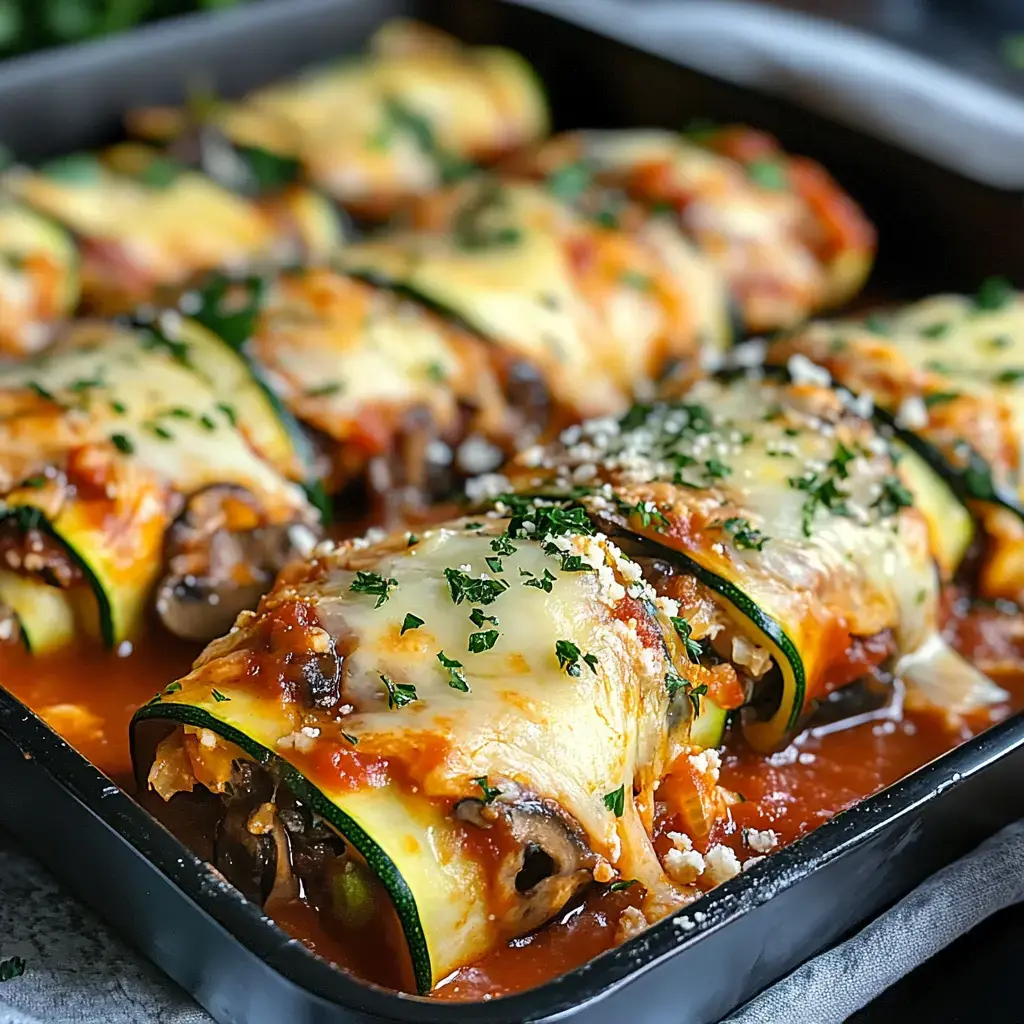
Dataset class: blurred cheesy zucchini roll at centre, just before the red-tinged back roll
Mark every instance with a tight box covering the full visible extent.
[338,175,727,423]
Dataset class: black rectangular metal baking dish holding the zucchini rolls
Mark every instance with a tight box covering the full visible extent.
[0,0,1024,1024]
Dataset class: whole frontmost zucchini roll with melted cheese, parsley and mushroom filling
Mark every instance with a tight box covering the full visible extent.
[133,512,741,991]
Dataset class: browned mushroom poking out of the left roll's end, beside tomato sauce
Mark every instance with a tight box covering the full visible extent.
[157,484,317,640]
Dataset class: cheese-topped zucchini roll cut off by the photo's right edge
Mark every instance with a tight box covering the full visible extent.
[768,279,1024,602]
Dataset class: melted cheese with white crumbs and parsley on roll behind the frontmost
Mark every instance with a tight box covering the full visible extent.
[513,380,1001,710]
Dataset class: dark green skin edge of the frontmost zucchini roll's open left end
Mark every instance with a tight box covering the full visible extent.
[130,697,432,995]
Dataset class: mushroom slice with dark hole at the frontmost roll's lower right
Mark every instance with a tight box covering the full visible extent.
[455,797,598,938]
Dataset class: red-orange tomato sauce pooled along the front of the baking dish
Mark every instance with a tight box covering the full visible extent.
[0,637,1024,999]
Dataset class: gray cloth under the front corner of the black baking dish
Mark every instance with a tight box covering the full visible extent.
[0,822,1024,1024]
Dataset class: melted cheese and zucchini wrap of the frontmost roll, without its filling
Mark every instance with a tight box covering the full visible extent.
[151,517,686,980]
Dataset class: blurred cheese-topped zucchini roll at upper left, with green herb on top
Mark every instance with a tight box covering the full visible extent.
[3,143,341,321]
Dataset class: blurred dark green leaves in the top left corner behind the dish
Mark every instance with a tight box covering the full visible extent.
[0,0,253,57]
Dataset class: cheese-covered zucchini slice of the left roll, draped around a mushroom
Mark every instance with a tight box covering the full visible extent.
[0,323,310,646]
